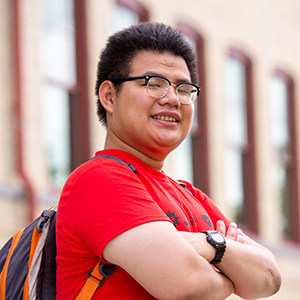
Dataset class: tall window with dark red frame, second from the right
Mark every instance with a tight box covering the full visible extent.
[225,49,257,232]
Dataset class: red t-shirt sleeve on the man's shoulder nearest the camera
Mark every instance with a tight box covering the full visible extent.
[64,159,170,258]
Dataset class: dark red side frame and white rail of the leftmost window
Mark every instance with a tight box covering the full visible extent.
[39,0,84,185]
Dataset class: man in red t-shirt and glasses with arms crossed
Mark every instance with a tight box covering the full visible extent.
[57,23,281,300]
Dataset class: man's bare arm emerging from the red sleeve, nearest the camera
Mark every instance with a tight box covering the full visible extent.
[103,222,234,300]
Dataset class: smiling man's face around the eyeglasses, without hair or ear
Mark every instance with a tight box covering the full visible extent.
[107,52,194,160]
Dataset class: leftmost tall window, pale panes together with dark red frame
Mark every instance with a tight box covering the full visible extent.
[41,0,91,188]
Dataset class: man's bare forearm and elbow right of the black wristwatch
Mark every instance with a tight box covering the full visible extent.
[217,239,281,299]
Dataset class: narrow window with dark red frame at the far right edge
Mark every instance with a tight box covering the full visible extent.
[269,71,300,242]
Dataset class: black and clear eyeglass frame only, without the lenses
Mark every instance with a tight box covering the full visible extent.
[111,75,201,105]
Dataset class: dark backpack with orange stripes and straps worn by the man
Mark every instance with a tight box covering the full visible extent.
[0,155,136,300]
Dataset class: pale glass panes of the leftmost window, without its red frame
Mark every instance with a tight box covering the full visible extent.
[41,0,76,186]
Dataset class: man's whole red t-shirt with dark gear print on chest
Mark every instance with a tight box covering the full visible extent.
[56,150,229,300]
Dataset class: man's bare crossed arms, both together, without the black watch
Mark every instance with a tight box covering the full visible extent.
[103,221,281,300]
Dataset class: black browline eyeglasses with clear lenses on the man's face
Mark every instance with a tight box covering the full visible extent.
[112,75,201,104]
